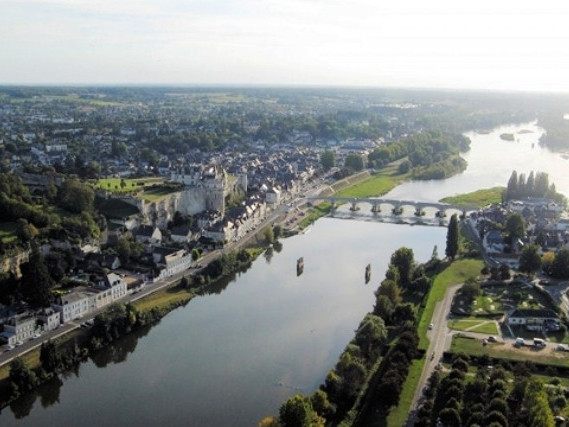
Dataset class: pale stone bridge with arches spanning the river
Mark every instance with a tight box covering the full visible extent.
[305,196,478,217]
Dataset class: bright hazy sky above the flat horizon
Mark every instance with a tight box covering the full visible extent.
[0,0,569,92]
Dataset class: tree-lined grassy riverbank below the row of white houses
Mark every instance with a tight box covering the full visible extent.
[0,246,265,409]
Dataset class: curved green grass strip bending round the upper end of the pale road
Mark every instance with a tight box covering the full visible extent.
[417,258,484,350]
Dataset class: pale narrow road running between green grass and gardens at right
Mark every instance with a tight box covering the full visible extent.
[407,283,462,426]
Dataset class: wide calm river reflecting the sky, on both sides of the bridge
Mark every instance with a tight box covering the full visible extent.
[0,119,569,426]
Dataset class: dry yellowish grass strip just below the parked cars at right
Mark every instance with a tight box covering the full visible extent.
[450,335,569,366]
